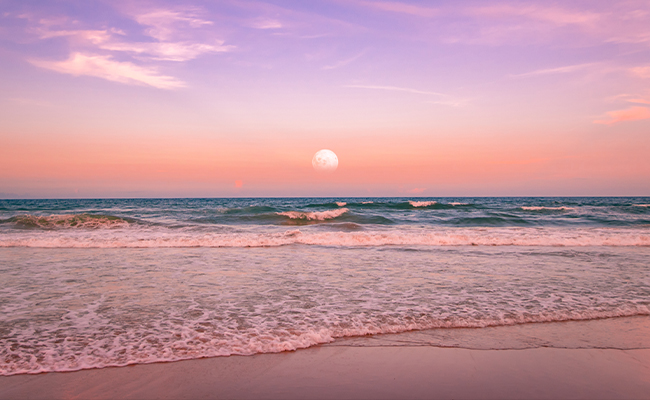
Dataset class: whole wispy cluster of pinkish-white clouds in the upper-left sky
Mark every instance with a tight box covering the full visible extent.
[15,9,234,89]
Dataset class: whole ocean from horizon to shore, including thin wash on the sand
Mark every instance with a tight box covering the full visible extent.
[0,197,650,375]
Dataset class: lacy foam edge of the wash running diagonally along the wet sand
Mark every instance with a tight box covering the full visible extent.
[0,305,650,376]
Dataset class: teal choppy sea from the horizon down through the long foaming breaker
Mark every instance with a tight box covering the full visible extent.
[0,197,650,247]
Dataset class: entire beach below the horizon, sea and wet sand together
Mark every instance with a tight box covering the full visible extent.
[0,198,650,399]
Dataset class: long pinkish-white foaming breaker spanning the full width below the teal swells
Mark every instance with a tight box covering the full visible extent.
[0,227,650,248]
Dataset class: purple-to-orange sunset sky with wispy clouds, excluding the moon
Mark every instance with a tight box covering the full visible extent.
[0,0,650,198]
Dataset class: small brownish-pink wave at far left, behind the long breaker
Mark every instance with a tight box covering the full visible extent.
[0,214,135,230]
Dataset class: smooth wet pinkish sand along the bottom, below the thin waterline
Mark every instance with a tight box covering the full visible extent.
[0,346,650,399]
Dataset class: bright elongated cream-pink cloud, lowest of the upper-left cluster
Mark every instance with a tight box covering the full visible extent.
[30,53,185,89]
